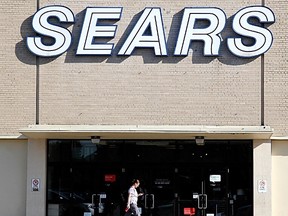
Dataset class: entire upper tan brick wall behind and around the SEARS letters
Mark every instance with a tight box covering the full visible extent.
[0,0,287,137]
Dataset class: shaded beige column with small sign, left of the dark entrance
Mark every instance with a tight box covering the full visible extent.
[26,139,47,216]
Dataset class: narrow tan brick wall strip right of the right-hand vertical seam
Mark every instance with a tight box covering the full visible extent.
[265,0,288,136]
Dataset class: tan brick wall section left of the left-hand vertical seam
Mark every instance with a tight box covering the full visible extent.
[0,0,36,135]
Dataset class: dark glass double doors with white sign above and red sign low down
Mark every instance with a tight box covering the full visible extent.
[176,167,229,216]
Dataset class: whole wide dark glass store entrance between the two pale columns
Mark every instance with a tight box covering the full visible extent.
[47,140,253,216]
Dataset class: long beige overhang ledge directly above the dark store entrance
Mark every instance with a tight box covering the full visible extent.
[19,125,273,139]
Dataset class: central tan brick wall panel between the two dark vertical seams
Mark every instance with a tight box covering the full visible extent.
[40,1,261,125]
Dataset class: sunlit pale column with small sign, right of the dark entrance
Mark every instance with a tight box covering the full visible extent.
[253,140,272,216]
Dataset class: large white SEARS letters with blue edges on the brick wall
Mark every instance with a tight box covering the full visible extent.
[27,6,275,58]
